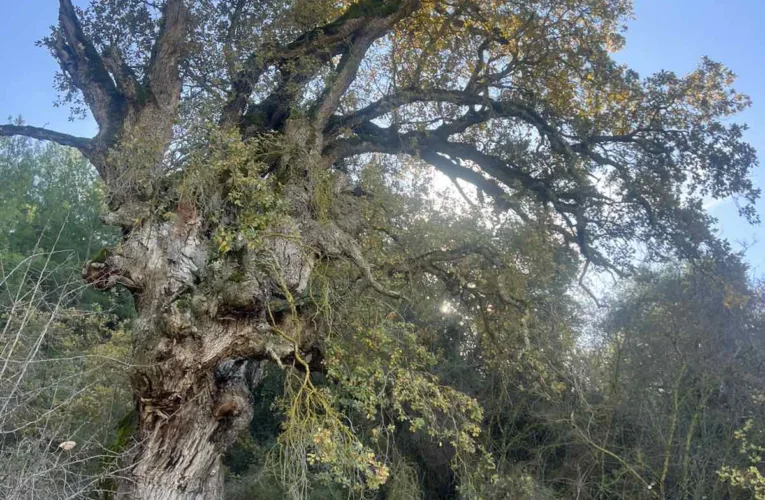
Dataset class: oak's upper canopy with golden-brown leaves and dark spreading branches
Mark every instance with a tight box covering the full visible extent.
[4,0,757,265]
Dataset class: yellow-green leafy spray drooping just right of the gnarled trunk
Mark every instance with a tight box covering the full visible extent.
[326,321,482,454]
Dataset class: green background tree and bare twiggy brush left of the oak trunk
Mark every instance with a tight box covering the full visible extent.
[0,138,131,499]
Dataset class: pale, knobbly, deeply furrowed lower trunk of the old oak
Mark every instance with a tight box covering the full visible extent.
[83,133,364,500]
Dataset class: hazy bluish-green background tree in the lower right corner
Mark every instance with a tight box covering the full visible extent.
[540,257,765,499]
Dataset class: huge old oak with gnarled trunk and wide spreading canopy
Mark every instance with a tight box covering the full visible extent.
[0,0,758,499]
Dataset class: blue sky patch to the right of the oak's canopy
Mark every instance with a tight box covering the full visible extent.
[617,0,765,276]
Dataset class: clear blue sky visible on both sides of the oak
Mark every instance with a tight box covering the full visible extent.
[0,0,765,276]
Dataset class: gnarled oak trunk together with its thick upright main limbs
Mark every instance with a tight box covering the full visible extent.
[0,0,406,488]
